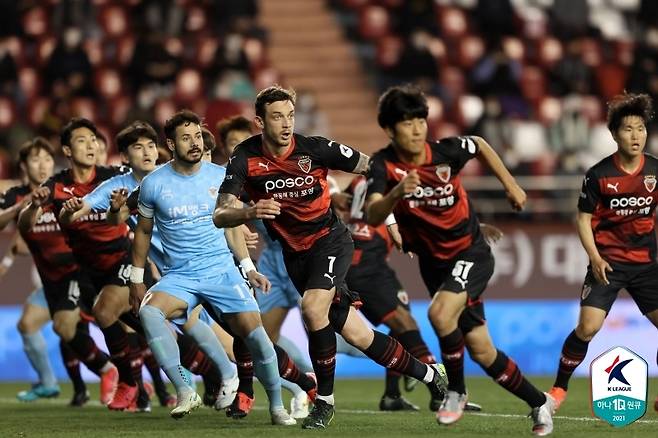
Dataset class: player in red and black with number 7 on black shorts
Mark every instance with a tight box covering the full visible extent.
[214,86,445,429]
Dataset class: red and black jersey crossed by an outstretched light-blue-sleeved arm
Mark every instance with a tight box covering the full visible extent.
[44,166,130,271]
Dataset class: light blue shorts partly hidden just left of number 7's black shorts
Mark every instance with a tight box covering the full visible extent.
[256,247,301,313]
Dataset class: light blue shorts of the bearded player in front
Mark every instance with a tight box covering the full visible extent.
[149,267,258,324]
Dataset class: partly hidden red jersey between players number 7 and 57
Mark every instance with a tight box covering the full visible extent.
[346,176,393,273]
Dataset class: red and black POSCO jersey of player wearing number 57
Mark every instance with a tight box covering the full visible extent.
[368,137,484,260]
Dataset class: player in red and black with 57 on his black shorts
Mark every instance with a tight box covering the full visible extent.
[366,87,553,435]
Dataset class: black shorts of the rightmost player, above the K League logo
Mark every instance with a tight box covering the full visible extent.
[580,262,658,315]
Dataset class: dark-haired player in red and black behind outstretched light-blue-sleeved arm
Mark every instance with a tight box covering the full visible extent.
[19,118,150,411]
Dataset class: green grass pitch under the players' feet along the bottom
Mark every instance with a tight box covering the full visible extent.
[0,378,658,438]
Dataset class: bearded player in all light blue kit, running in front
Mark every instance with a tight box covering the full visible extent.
[130,110,296,425]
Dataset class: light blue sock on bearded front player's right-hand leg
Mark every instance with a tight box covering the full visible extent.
[244,326,283,411]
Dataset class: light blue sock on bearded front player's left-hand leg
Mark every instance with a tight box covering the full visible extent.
[139,305,194,394]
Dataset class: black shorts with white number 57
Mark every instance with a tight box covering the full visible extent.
[418,244,495,333]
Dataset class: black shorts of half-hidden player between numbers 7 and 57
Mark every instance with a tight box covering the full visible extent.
[345,261,409,326]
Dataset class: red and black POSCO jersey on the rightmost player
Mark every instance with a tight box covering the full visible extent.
[578,153,658,263]
